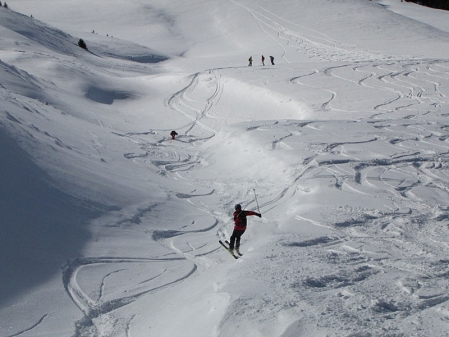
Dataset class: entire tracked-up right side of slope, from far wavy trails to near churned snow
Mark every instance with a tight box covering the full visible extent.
[234,60,449,330]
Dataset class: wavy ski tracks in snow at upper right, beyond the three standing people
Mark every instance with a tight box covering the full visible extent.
[290,60,449,118]
